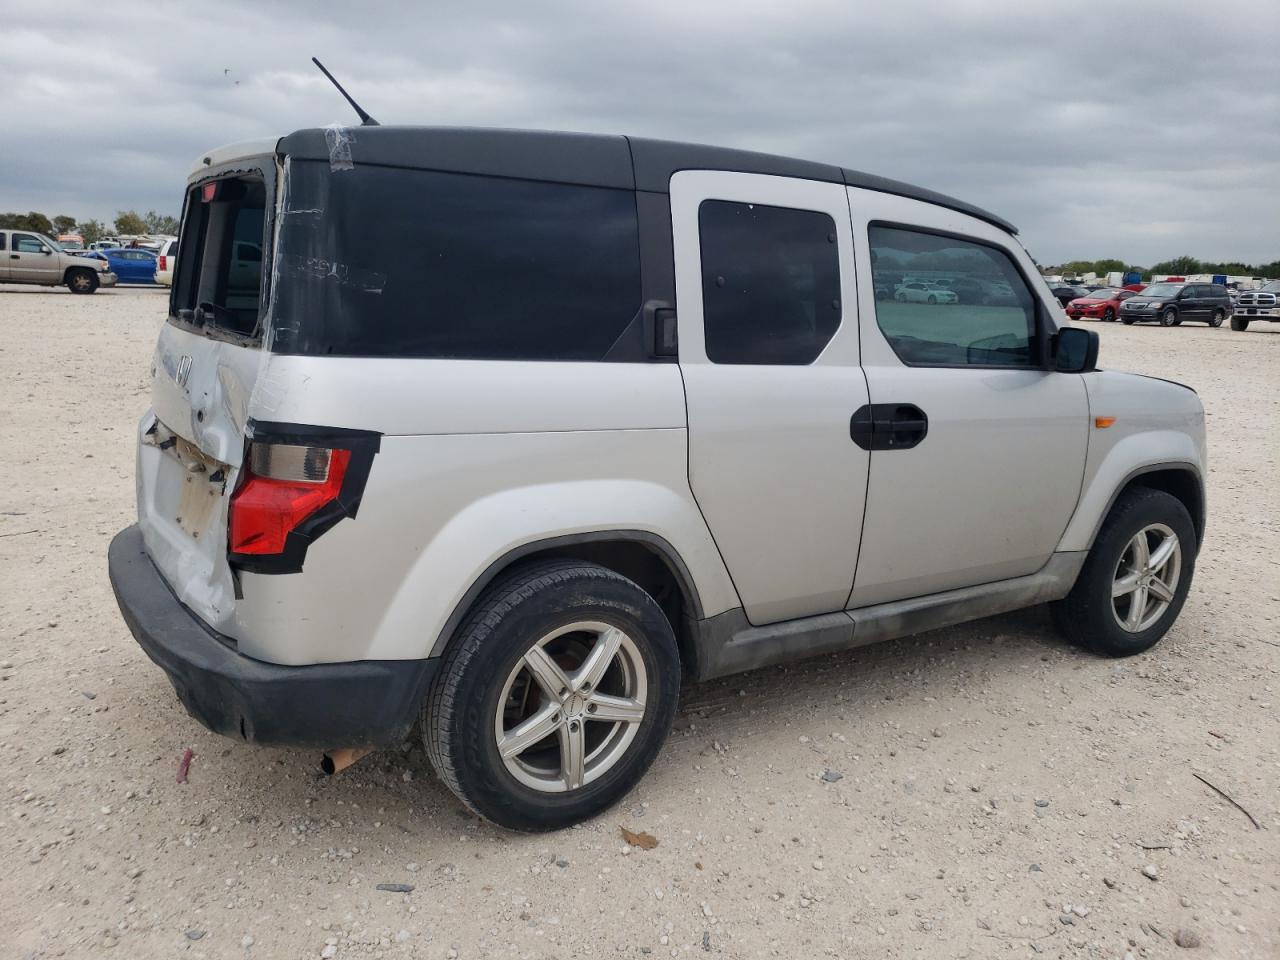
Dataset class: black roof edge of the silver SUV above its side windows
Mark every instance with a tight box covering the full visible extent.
[276,127,1018,233]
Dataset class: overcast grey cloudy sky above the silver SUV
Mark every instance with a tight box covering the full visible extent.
[0,0,1280,264]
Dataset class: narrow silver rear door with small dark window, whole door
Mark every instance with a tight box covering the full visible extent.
[671,170,872,625]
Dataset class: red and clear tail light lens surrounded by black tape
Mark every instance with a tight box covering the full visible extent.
[229,443,351,556]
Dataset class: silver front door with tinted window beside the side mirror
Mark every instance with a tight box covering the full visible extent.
[849,189,1089,607]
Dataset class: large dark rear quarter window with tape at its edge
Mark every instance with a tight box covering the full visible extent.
[275,160,640,361]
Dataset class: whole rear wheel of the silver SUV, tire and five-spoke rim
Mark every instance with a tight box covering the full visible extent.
[422,561,680,831]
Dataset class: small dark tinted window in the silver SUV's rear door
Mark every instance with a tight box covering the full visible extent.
[698,200,841,365]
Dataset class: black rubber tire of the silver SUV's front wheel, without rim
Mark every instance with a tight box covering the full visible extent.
[1071,489,1197,657]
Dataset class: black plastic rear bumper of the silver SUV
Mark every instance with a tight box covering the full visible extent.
[108,525,439,749]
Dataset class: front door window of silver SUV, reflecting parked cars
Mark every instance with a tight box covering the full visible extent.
[868,225,1039,366]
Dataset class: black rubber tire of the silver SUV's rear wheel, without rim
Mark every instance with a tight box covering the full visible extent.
[440,568,680,831]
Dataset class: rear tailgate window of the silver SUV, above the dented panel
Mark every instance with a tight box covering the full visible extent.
[171,177,268,337]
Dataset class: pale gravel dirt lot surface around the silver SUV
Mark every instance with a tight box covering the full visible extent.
[0,287,1280,959]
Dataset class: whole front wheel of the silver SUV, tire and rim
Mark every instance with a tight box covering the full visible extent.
[1051,486,1197,657]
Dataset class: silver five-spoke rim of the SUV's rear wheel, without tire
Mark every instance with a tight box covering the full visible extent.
[494,621,649,794]
